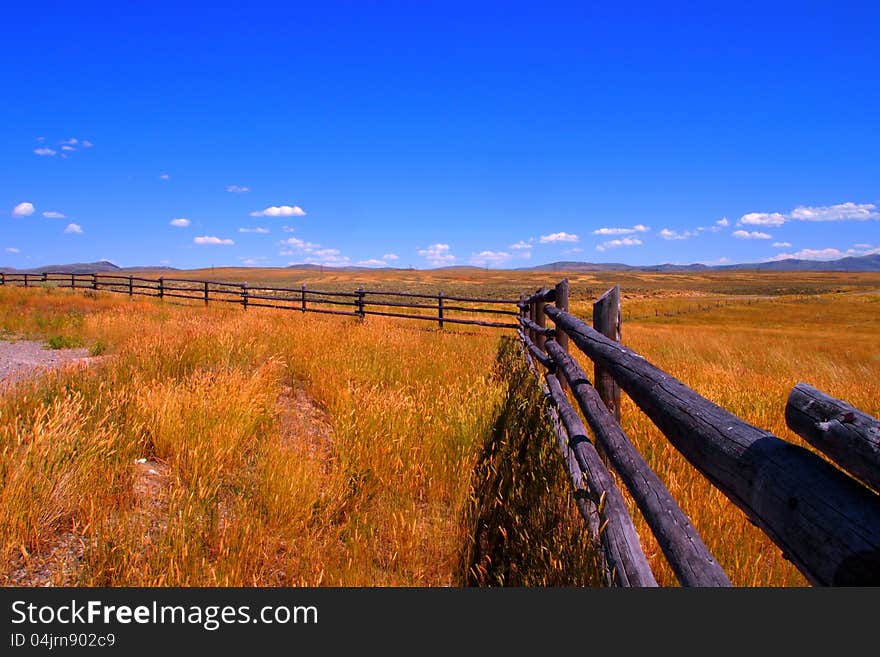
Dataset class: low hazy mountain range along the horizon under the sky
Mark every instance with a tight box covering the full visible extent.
[0,253,880,274]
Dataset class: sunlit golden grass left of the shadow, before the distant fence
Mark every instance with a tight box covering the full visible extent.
[0,289,501,585]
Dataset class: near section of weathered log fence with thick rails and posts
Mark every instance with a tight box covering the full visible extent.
[519,281,880,586]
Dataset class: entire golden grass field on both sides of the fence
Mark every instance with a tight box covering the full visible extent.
[0,270,880,586]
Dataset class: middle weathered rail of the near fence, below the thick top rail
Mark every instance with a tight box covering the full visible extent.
[545,340,730,586]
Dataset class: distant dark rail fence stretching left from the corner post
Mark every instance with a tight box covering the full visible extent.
[0,272,519,329]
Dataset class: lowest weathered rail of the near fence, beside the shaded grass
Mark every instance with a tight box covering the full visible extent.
[544,373,657,586]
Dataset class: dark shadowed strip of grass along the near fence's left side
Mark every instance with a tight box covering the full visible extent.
[459,337,602,587]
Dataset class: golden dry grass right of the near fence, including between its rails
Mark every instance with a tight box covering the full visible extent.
[581,295,880,586]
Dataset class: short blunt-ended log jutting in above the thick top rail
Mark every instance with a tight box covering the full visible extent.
[785,383,880,491]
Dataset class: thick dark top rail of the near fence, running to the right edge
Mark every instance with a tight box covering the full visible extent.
[545,305,880,586]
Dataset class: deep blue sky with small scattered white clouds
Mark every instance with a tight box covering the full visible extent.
[0,1,880,268]
